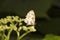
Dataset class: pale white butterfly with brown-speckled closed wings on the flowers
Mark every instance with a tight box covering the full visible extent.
[24,10,35,25]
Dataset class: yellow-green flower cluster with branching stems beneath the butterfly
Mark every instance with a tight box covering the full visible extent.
[0,16,36,40]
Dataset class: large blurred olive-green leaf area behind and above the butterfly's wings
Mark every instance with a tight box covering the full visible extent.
[0,0,53,17]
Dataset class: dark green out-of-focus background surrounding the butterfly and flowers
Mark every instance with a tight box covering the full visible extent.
[0,0,60,40]
